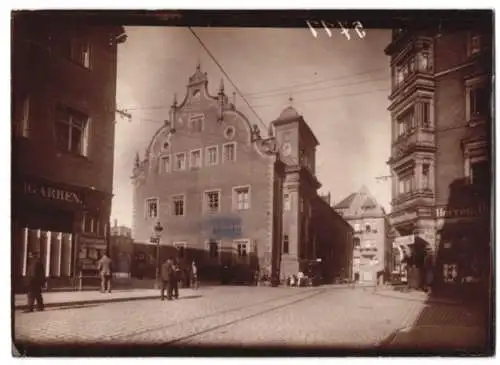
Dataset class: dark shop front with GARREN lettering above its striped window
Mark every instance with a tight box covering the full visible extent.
[12,176,110,286]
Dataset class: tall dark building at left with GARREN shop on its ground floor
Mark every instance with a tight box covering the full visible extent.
[12,12,125,286]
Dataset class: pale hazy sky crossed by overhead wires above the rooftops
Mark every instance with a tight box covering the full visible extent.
[112,27,390,226]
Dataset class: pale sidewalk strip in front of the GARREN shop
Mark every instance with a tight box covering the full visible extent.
[14,288,199,309]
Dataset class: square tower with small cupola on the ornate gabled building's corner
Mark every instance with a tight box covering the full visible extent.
[273,106,321,279]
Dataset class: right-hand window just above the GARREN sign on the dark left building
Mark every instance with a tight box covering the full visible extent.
[55,107,89,156]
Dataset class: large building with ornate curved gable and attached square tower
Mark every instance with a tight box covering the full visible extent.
[132,66,351,283]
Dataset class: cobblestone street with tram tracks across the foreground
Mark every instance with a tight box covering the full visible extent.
[15,287,480,348]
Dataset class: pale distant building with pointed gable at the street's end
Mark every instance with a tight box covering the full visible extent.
[334,186,394,282]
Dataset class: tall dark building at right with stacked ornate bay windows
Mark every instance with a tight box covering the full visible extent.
[385,24,492,291]
